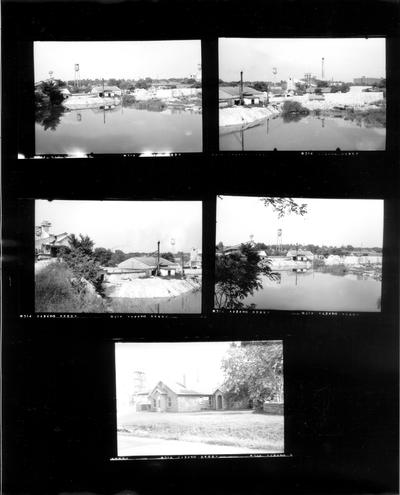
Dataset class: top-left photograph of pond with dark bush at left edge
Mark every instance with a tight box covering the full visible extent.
[34,40,202,156]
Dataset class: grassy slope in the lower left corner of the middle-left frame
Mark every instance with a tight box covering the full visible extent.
[35,262,105,313]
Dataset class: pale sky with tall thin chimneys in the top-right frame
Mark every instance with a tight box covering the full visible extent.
[219,38,386,82]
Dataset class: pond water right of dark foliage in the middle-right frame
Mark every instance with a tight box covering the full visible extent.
[243,270,381,312]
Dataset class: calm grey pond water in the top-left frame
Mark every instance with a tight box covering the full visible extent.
[35,105,202,154]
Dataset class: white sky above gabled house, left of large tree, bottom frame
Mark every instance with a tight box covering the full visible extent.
[115,342,231,403]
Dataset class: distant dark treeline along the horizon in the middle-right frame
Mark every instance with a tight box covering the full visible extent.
[217,242,382,256]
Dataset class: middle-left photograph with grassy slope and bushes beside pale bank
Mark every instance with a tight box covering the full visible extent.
[34,200,202,313]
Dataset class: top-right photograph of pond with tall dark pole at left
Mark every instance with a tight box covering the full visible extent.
[219,38,386,151]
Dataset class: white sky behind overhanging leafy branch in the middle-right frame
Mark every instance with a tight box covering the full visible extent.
[216,196,383,248]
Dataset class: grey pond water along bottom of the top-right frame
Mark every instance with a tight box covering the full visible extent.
[220,115,386,151]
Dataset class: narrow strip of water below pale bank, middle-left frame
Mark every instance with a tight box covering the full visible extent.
[108,290,201,314]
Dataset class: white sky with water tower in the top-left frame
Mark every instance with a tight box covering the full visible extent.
[34,40,201,82]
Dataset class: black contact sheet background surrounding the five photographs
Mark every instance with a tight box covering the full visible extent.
[2,0,400,494]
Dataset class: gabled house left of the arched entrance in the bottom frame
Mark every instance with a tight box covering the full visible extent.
[148,381,210,412]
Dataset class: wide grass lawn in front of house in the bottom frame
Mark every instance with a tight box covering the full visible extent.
[118,411,284,452]
